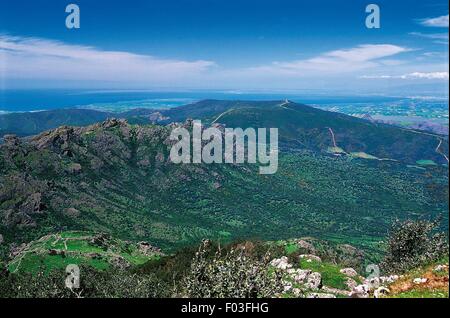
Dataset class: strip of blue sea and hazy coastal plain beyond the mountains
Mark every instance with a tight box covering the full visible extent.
[0,89,449,127]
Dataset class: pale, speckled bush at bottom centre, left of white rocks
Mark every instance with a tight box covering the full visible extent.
[181,241,283,298]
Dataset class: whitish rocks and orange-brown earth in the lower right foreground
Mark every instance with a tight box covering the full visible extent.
[271,254,449,298]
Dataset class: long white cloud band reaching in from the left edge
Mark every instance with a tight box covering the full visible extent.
[0,34,215,84]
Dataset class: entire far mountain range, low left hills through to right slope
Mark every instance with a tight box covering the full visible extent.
[0,100,448,164]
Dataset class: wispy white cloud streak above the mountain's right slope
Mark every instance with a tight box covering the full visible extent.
[243,44,410,76]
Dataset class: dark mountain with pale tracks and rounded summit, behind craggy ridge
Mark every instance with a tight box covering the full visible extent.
[160,100,448,164]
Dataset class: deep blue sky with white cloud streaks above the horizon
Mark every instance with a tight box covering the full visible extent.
[0,0,449,93]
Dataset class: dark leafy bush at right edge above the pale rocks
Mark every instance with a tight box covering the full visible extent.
[381,220,448,273]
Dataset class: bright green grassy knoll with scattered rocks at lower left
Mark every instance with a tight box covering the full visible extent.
[8,231,163,273]
